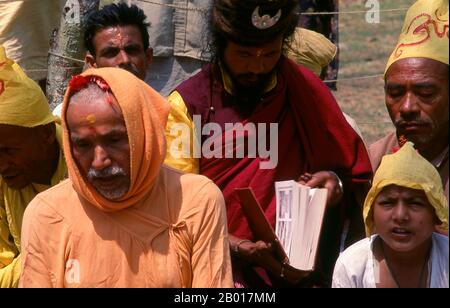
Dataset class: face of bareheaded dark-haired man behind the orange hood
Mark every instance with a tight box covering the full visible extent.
[86,25,153,80]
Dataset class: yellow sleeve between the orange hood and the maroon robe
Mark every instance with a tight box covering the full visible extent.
[164,91,199,174]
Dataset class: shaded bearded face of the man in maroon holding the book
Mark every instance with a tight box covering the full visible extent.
[223,38,283,88]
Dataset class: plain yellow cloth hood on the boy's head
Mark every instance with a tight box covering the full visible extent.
[363,142,448,236]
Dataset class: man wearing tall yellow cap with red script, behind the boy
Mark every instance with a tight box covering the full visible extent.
[369,0,449,199]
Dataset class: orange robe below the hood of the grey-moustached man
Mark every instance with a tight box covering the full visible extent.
[20,167,233,288]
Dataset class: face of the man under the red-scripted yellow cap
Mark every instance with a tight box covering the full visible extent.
[386,58,449,152]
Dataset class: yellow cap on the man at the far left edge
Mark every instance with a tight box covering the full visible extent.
[0,45,55,127]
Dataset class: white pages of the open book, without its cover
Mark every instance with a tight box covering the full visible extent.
[275,181,328,271]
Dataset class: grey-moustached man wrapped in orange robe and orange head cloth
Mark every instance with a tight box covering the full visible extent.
[20,68,232,288]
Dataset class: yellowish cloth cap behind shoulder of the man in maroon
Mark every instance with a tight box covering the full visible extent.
[286,27,337,75]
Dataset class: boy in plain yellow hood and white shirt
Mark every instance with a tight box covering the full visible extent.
[333,142,449,288]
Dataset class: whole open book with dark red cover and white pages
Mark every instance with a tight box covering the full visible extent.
[235,181,327,271]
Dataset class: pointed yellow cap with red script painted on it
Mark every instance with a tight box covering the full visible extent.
[385,0,449,74]
